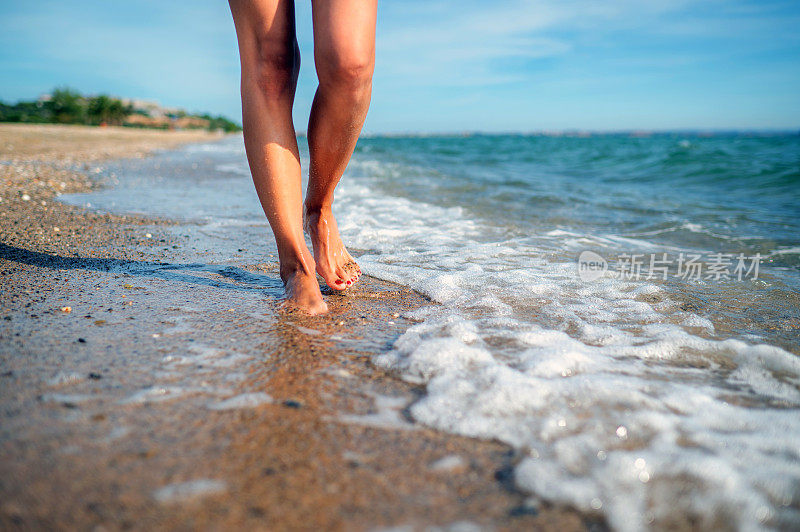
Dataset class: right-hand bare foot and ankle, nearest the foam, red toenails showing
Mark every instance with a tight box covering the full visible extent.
[303,206,361,290]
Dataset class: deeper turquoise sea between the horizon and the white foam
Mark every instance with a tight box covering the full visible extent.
[356,134,800,270]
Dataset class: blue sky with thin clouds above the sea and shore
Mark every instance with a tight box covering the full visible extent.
[0,0,800,133]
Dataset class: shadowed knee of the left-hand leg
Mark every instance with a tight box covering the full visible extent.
[247,39,300,100]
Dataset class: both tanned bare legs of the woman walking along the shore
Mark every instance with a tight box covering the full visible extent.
[229,0,377,314]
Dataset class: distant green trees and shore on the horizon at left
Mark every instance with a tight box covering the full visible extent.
[0,88,242,133]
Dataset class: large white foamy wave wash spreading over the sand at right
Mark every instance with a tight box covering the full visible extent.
[337,161,800,531]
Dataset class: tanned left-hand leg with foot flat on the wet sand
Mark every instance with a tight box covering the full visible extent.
[229,0,327,314]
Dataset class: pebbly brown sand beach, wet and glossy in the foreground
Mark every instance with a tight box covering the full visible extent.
[0,125,588,530]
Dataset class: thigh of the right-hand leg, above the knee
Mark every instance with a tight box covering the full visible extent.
[312,0,378,76]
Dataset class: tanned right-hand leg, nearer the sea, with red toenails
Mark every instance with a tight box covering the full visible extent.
[304,0,377,289]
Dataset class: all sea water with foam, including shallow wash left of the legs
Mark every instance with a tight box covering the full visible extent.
[62,134,800,530]
